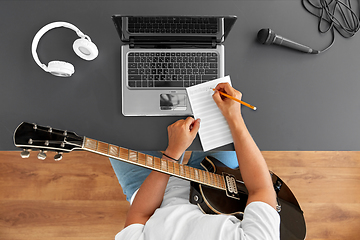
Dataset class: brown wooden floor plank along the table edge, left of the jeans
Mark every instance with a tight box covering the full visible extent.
[0,152,122,200]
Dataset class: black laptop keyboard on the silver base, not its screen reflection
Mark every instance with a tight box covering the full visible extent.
[128,51,219,88]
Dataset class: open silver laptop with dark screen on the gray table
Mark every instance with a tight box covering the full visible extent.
[112,15,237,116]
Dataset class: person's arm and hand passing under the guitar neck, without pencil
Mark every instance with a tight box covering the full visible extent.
[125,117,200,227]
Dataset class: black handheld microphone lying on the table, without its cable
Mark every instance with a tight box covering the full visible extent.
[257,28,320,54]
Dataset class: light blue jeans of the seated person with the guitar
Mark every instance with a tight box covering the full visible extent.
[110,151,239,202]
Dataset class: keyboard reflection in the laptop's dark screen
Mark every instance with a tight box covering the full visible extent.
[128,17,218,34]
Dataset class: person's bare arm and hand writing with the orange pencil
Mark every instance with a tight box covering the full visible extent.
[213,83,277,209]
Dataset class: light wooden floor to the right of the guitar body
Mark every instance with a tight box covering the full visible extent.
[262,151,360,240]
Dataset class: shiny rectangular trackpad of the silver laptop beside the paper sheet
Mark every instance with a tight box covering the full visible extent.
[160,93,187,111]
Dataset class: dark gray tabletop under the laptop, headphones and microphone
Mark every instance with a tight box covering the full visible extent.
[0,0,360,150]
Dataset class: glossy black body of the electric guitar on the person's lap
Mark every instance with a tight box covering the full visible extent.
[189,156,306,240]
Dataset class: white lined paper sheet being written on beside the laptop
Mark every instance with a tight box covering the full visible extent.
[186,76,233,151]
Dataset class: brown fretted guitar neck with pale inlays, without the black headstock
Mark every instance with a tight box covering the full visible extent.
[82,137,226,190]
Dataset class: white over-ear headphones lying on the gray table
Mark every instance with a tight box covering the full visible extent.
[31,22,99,77]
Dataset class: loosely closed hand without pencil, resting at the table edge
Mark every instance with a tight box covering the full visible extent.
[165,117,200,159]
